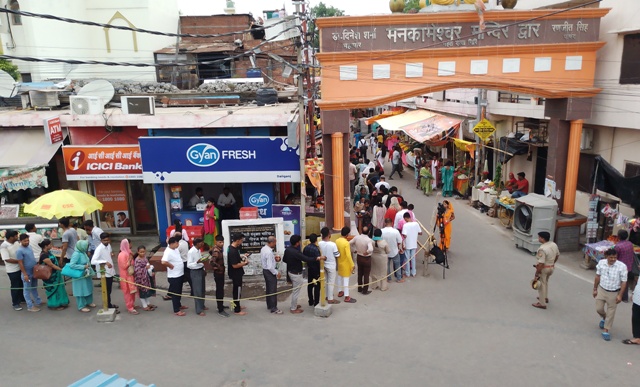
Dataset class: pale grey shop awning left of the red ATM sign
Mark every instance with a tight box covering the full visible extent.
[0,128,67,168]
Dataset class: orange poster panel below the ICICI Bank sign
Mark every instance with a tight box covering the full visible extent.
[93,180,131,232]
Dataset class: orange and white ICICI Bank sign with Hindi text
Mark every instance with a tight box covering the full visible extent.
[62,145,142,180]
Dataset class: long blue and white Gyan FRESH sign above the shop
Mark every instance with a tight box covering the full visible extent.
[138,137,300,184]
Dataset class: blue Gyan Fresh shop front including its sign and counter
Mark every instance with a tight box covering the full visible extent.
[139,136,301,243]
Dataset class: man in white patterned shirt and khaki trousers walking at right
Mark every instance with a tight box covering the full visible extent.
[593,249,628,341]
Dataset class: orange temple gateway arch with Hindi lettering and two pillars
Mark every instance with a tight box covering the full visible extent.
[316,8,609,229]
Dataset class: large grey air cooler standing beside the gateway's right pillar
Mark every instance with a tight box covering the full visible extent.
[513,194,558,254]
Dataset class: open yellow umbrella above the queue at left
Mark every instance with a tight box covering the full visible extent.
[24,189,102,219]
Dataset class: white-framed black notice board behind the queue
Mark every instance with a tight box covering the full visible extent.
[222,218,286,275]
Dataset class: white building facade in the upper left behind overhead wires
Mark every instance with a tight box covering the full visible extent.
[0,0,179,82]
